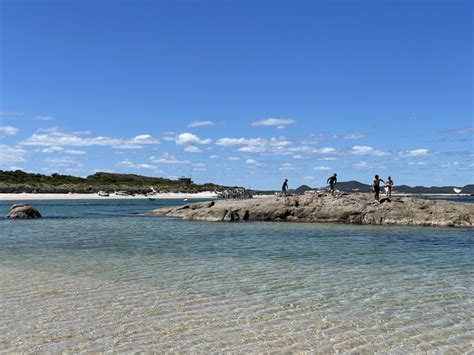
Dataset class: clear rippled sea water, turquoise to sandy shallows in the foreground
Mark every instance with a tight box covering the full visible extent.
[0,200,474,353]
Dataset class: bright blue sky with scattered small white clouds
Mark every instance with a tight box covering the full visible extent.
[0,0,474,189]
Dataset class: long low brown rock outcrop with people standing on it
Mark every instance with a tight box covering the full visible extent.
[148,193,474,227]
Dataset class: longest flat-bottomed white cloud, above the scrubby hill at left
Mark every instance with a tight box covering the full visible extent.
[21,127,160,149]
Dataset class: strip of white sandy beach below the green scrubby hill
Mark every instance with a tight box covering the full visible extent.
[0,191,217,201]
